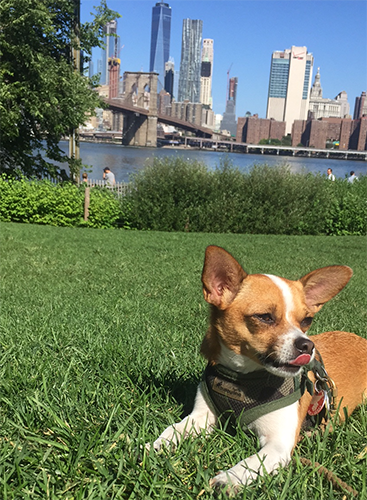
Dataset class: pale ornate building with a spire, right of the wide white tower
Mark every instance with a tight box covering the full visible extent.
[309,68,349,120]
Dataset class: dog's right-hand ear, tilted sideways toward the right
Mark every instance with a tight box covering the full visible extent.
[300,266,353,313]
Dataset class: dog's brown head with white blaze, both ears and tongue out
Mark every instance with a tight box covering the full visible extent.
[202,246,353,376]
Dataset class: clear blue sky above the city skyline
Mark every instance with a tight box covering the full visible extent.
[81,0,367,117]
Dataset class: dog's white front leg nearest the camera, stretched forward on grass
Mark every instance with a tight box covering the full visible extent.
[210,401,299,493]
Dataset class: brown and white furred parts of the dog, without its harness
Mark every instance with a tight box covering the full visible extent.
[153,246,367,491]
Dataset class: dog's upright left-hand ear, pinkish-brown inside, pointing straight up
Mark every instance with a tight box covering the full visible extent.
[201,245,247,309]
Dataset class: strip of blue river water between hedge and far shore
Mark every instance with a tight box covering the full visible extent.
[61,142,367,182]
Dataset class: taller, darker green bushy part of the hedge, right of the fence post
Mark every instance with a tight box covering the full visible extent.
[124,158,367,235]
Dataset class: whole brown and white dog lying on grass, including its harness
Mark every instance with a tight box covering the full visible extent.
[153,246,367,493]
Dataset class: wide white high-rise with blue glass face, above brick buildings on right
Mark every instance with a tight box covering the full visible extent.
[266,46,313,134]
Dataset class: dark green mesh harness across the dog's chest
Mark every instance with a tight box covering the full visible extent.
[202,364,306,426]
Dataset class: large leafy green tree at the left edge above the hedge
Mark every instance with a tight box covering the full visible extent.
[0,0,120,177]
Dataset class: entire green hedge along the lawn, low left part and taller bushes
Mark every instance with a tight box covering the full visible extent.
[0,158,367,235]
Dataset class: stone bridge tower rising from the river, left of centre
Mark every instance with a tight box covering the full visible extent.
[122,71,158,147]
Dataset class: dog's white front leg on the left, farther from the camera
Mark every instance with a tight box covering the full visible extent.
[153,384,217,450]
